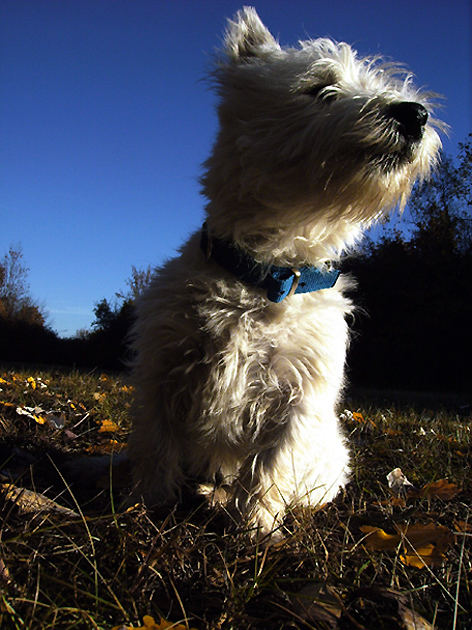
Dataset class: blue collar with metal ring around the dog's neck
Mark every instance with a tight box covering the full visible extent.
[200,223,341,302]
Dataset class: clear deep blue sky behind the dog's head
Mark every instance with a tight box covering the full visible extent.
[0,0,472,335]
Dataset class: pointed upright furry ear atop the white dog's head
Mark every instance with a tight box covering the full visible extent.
[225,7,280,63]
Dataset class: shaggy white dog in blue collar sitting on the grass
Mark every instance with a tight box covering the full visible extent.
[130,8,440,535]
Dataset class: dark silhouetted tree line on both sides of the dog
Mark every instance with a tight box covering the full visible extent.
[0,134,472,392]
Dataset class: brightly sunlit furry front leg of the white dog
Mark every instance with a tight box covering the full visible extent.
[230,400,349,540]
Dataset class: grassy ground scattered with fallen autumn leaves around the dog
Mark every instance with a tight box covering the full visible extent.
[0,370,472,630]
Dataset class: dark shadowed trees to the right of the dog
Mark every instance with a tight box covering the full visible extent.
[345,134,472,392]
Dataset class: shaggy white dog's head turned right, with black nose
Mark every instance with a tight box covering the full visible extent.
[203,8,441,262]
